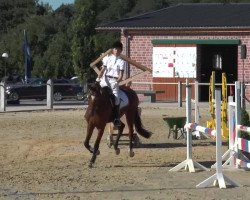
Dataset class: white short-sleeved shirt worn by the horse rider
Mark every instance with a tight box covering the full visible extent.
[102,54,125,78]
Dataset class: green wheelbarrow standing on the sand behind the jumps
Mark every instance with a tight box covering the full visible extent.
[163,115,186,139]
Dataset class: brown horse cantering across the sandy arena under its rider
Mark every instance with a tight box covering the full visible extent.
[84,83,152,167]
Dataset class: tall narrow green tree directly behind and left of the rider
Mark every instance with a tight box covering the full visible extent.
[71,0,96,80]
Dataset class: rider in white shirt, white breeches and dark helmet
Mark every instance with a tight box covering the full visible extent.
[96,41,125,126]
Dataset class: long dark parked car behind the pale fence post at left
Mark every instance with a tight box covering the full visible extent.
[6,79,85,102]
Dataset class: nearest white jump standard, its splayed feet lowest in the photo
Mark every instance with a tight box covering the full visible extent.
[196,89,240,189]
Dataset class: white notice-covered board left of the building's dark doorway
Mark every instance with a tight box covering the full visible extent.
[153,47,197,78]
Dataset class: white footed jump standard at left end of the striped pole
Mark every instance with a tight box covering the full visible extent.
[169,79,208,172]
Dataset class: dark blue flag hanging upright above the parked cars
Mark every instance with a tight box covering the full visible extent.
[24,30,31,83]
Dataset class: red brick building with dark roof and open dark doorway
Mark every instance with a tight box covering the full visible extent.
[97,3,250,101]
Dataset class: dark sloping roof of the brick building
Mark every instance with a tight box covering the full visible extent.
[97,3,250,30]
